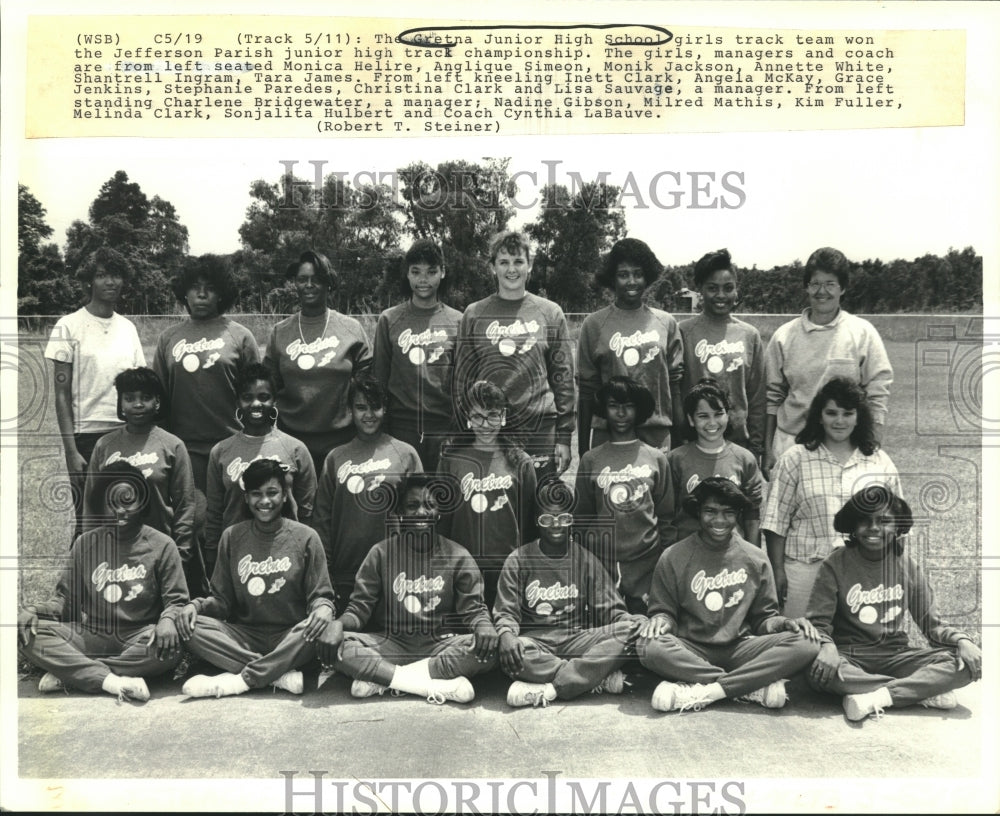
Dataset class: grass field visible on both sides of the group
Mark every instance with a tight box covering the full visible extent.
[13,317,982,642]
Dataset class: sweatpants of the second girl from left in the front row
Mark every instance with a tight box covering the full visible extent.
[187,616,316,688]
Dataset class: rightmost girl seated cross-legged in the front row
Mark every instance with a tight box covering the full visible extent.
[806,485,982,721]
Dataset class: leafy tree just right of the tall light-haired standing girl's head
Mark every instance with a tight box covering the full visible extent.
[526,181,625,312]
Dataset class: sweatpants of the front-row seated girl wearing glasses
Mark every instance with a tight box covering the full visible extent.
[511,621,636,700]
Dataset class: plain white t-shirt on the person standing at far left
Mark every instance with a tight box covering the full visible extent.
[45,308,146,433]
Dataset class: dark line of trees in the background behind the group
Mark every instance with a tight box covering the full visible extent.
[18,167,983,315]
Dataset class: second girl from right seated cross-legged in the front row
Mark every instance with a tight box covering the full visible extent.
[636,477,819,711]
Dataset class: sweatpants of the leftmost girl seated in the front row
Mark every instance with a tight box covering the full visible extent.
[18,620,180,692]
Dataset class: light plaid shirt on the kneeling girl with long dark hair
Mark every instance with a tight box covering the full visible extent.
[760,444,903,561]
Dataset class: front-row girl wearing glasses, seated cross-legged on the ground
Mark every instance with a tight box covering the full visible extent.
[493,482,646,707]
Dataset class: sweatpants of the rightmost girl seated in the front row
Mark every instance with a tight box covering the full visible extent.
[809,646,972,707]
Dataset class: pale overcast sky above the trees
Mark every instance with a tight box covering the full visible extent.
[19,128,996,267]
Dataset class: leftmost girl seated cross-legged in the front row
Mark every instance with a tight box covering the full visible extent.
[18,461,188,701]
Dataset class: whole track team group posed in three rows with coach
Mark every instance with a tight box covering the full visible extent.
[19,232,982,720]
